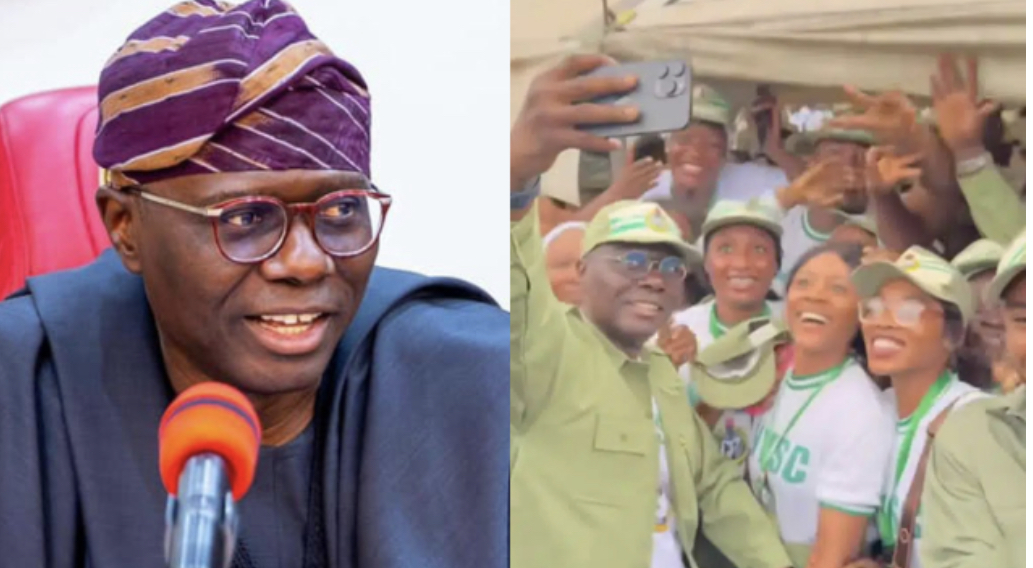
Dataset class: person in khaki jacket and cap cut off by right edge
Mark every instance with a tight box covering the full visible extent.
[920,230,1026,568]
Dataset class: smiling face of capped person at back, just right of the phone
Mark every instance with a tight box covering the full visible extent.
[667,122,728,191]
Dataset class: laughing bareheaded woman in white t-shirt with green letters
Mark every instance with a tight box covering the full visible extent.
[748,244,894,568]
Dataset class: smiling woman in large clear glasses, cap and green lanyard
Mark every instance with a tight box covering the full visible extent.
[852,247,984,568]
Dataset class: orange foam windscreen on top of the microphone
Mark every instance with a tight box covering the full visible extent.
[158,382,261,501]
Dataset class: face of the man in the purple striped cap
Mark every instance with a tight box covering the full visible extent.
[102,170,377,396]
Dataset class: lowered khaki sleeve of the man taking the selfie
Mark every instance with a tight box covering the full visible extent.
[692,412,792,568]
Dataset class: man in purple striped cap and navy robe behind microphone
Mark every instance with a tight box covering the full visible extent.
[0,0,509,568]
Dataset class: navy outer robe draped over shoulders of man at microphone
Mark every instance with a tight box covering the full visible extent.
[0,251,509,568]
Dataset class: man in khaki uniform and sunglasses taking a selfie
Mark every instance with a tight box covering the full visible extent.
[510,56,789,568]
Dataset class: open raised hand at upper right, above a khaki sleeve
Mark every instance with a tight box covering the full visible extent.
[929,55,998,157]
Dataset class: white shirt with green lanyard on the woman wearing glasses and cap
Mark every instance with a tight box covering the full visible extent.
[878,373,985,568]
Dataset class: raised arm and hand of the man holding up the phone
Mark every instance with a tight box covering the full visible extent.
[509,56,636,428]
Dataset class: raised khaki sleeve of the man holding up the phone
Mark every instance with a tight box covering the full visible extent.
[509,198,568,429]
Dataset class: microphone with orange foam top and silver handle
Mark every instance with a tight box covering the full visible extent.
[158,382,261,568]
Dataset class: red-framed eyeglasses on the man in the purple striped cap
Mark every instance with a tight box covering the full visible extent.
[124,186,392,264]
